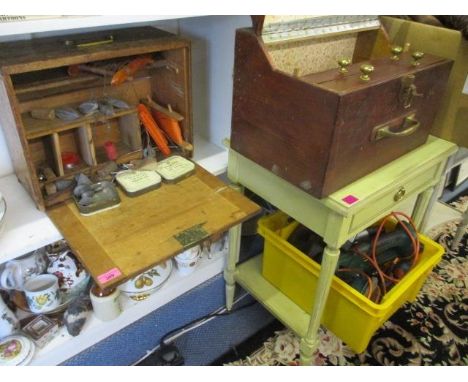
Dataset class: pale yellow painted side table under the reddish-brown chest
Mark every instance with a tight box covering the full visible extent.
[224,136,457,364]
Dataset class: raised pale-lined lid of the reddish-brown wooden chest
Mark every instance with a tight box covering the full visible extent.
[252,15,380,44]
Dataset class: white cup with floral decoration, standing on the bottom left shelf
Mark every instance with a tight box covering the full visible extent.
[24,274,60,313]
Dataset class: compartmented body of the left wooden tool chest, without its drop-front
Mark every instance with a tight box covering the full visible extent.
[0,27,193,209]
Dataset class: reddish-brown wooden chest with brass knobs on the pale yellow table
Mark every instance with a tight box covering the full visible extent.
[231,16,452,198]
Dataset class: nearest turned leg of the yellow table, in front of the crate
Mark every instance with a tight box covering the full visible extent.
[300,245,340,365]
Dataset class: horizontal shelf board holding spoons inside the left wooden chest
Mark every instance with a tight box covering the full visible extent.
[22,108,136,139]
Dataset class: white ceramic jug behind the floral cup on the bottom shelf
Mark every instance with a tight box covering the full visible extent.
[0,249,47,291]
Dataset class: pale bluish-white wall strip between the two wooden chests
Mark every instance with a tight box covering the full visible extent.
[179,16,252,146]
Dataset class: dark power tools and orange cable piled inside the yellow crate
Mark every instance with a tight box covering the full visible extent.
[288,212,422,302]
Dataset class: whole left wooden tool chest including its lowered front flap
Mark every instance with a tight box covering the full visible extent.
[0,27,259,289]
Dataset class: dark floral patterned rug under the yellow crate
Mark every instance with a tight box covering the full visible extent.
[228,197,468,366]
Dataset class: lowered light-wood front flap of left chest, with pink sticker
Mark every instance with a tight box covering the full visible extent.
[48,166,260,288]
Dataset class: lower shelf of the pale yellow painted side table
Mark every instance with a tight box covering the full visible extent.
[234,255,310,337]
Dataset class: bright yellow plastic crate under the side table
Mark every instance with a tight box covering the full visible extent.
[258,212,444,353]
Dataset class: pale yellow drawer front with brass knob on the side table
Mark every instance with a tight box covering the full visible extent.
[349,158,443,235]
